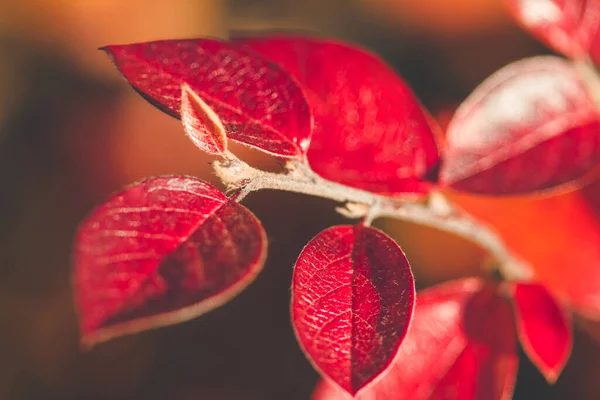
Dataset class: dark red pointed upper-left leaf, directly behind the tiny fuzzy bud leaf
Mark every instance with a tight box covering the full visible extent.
[103,39,311,157]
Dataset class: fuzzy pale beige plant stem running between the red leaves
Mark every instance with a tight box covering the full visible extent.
[213,159,531,280]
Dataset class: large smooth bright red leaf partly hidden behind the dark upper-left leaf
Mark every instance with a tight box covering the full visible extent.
[235,36,439,195]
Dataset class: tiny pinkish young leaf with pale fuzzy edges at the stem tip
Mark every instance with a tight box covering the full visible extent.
[181,83,227,155]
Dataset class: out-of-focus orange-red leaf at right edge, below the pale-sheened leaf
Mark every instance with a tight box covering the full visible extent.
[450,188,600,320]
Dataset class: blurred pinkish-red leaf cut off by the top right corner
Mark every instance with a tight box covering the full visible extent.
[507,0,600,58]
